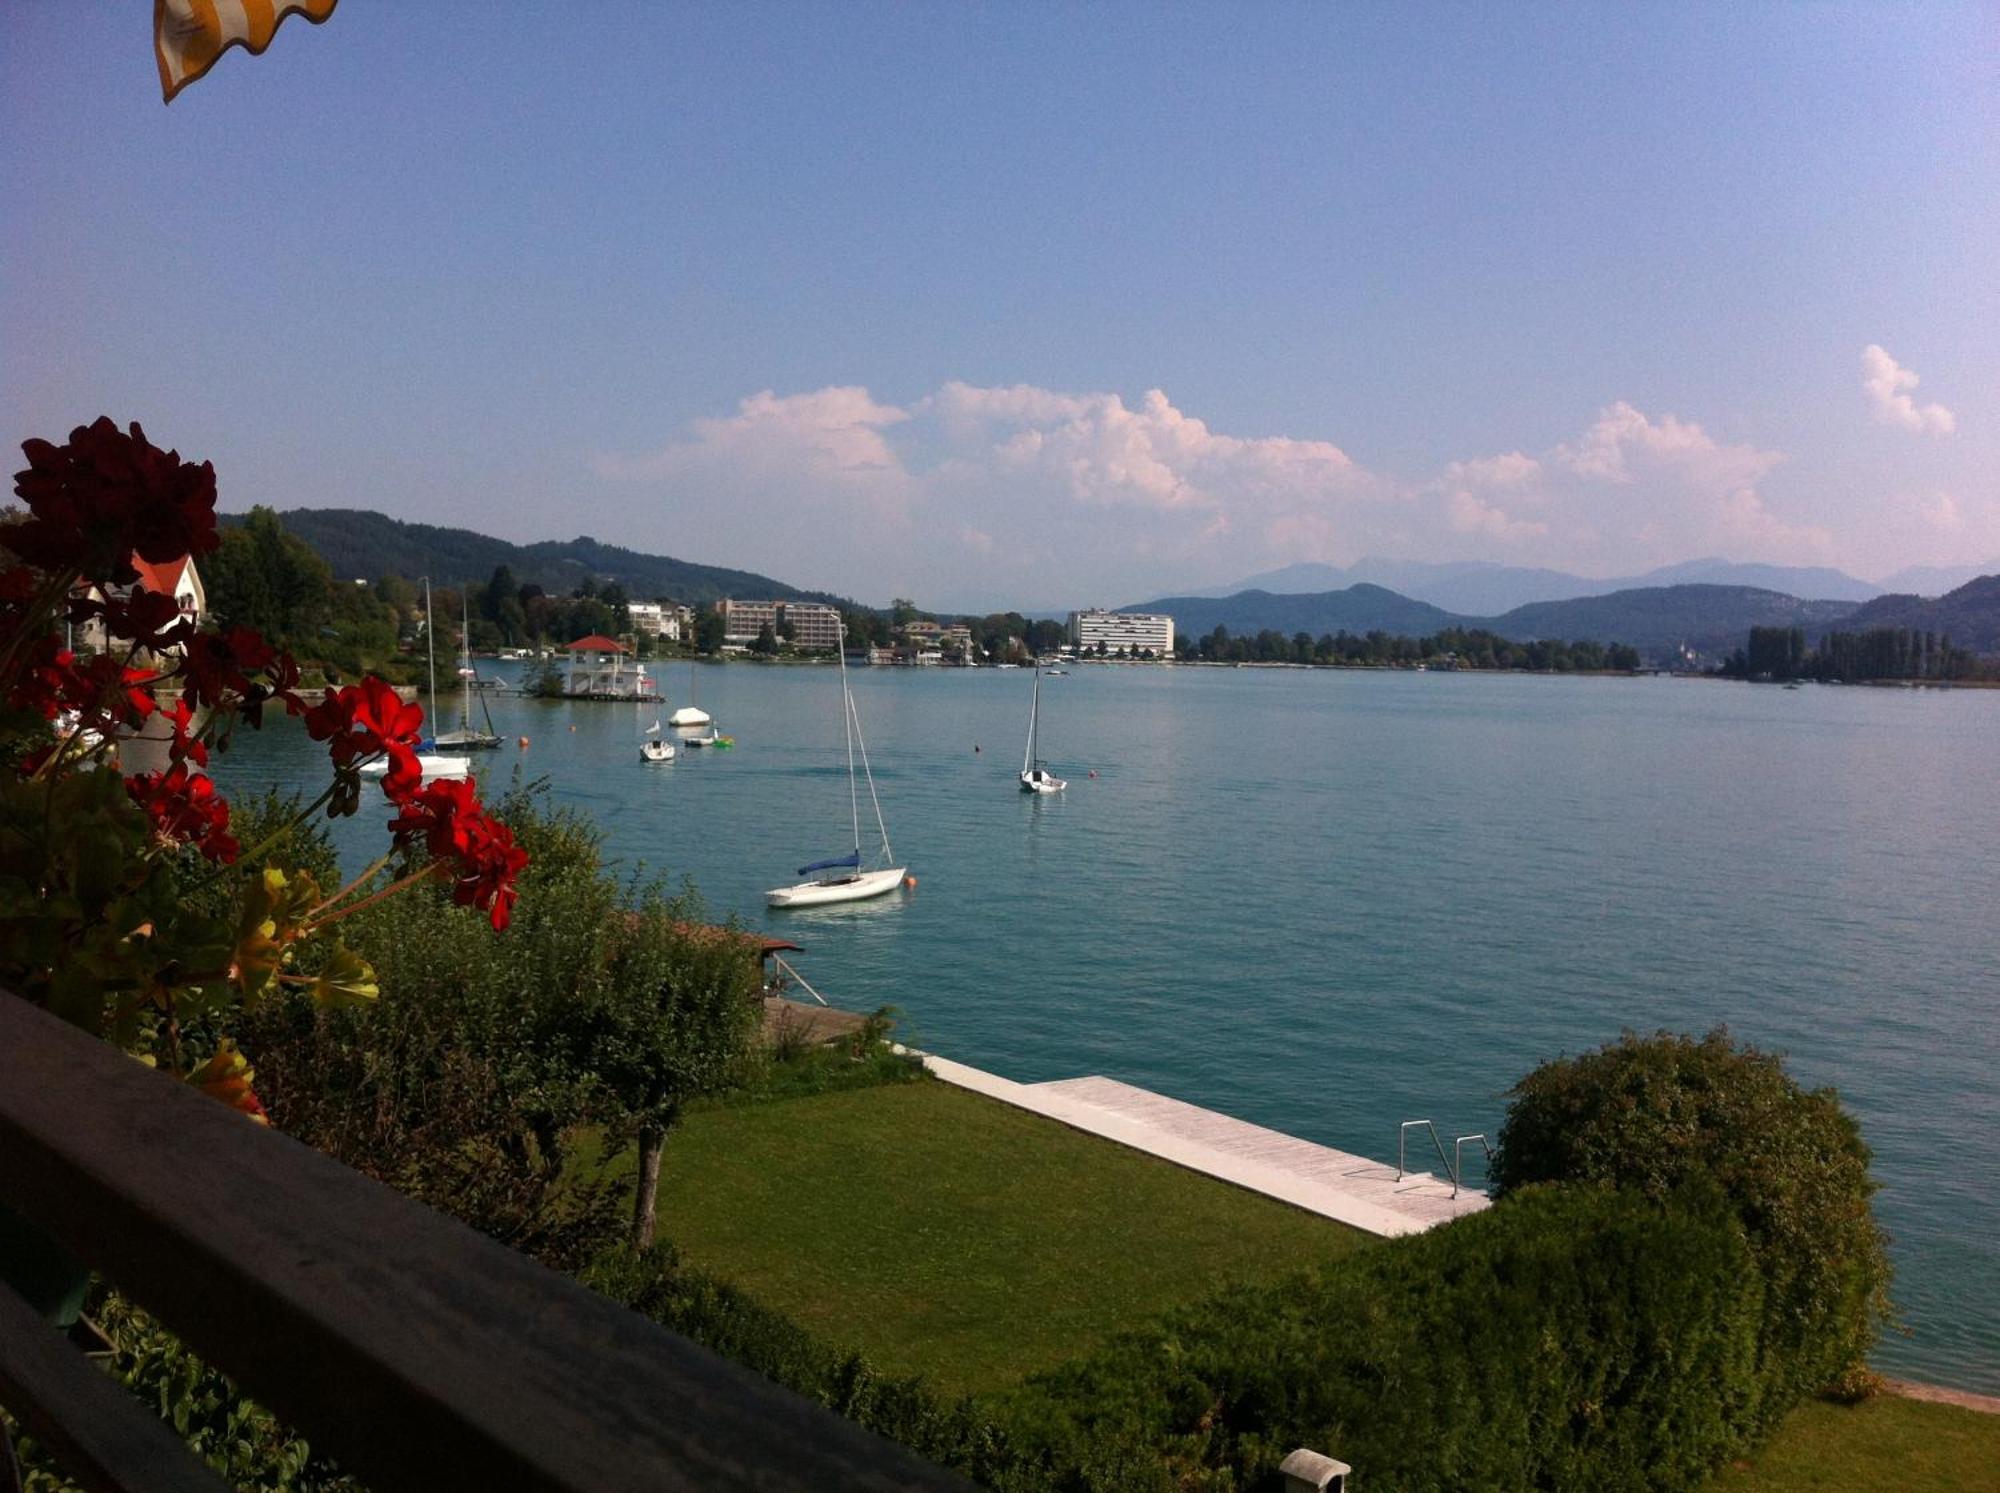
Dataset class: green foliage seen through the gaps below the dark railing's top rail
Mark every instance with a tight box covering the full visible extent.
[0,1293,360,1493]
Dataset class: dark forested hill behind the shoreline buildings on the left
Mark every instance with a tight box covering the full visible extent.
[222,508,844,606]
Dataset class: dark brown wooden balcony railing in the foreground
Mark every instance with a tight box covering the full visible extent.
[0,993,968,1493]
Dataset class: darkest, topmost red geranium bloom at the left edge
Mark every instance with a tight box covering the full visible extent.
[8,416,216,584]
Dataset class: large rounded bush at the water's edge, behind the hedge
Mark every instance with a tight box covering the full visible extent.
[1492,1029,1890,1425]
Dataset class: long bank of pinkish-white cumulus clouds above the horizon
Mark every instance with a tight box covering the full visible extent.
[596,382,1830,604]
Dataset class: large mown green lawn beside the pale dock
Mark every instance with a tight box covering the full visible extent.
[660,1081,1370,1393]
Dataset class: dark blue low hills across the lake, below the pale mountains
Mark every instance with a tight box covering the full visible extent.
[1132,584,1872,652]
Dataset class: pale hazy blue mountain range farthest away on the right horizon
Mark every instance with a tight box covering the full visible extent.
[1186,554,2000,616]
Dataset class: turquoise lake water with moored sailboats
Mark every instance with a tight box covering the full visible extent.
[224,666,2000,1393]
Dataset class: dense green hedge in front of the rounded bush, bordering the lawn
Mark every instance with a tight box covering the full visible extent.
[996,1189,1762,1493]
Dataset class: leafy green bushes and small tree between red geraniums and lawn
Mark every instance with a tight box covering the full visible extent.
[242,789,760,1269]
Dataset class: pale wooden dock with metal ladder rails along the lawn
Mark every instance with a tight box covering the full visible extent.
[924,1055,1490,1237]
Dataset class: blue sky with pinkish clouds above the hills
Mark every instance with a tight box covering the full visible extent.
[0,0,2000,608]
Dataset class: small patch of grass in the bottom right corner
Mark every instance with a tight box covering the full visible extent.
[1710,1397,2000,1493]
